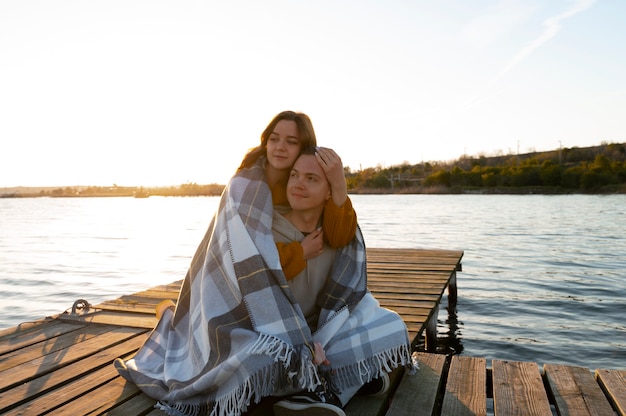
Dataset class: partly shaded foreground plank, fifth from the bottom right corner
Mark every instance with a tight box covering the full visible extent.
[386,352,446,416]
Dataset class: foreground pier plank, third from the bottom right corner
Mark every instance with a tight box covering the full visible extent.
[491,360,552,416]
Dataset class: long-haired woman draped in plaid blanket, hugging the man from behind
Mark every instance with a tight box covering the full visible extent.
[115,111,356,415]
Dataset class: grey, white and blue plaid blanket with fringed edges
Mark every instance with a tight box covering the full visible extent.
[115,159,411,415]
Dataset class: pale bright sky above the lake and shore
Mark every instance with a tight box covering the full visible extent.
[0,0,626,187]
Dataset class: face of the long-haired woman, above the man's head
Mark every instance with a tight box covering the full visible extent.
[265,120,301,170]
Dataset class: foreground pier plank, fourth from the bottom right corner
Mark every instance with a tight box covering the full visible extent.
[441,355,487,416]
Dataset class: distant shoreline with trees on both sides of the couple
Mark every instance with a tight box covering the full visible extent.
[0,143,626,198]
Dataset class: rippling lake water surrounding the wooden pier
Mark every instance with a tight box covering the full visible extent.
[0,195,626,369]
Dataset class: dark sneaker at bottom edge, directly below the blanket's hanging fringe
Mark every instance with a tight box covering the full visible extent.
[274,385,346,416]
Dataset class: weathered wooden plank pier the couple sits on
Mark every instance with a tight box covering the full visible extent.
[0,249,626,416]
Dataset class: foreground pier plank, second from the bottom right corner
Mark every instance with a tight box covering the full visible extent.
[543,364,613,416]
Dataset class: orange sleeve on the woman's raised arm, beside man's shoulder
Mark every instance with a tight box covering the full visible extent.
[322,197,356,248]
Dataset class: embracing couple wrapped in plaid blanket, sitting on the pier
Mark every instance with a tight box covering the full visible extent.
[115,111,411,416]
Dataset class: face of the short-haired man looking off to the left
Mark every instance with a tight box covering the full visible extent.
[287,155,331,210]
